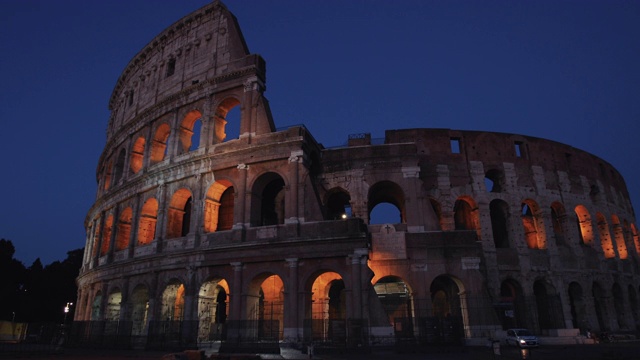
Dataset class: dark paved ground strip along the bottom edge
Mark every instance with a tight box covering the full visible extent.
[0,342,640,360]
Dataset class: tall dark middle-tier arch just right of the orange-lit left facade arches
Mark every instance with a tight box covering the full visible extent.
[251,172,285,226]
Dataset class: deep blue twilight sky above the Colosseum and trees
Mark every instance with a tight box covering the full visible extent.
[0,0,640,266]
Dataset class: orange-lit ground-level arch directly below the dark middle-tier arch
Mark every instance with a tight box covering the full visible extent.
[247,274,284,341]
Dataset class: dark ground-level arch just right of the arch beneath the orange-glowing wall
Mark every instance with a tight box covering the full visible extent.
[425,275,467,344]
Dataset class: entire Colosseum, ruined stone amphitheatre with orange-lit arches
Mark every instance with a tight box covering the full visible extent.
[71,1,640,351]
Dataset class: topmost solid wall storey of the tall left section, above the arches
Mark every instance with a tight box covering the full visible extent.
[107,1,254,139]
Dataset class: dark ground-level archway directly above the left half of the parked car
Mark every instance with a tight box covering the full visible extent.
[497,279,528,330]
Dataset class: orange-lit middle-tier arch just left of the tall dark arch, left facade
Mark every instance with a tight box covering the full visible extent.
[203,180,235,233]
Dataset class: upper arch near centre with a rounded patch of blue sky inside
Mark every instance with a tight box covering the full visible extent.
[367,181,406,224]
